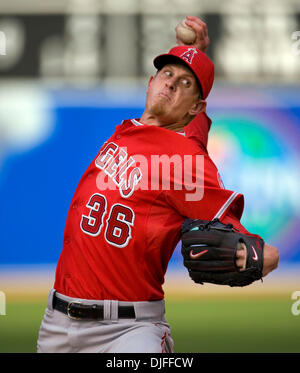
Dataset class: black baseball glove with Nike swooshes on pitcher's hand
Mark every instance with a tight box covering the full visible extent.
[181,219,264,286]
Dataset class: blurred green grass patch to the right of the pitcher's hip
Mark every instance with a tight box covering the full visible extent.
[167,297,300,353]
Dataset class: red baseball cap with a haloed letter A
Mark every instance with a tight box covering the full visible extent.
[153,45,215,100]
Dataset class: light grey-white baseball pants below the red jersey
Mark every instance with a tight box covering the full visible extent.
[37,289,174,353]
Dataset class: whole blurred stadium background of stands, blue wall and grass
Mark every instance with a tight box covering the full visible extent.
[0,0,300,352]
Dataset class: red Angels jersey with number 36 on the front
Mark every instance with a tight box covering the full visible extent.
[54,120,243,301]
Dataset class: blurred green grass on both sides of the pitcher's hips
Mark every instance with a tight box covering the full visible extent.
[0,295,300,352]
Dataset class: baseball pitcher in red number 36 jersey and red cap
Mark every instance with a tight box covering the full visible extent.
[37,16,278,353]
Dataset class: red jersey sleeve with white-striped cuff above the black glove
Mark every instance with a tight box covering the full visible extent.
[165,154,244,220]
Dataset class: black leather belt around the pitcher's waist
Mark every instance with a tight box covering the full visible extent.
[53,294,135,320]
